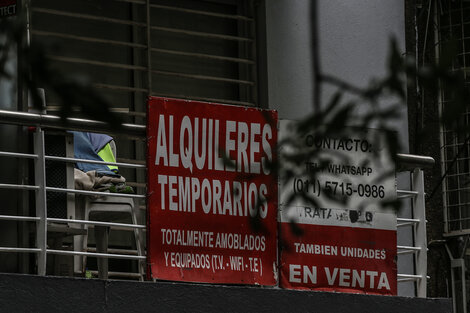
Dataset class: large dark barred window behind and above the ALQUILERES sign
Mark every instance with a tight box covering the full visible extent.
[30,0,257,187]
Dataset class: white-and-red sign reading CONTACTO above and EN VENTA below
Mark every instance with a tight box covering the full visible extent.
[280,121,397,295]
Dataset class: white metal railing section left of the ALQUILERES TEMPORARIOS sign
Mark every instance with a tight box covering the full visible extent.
[0,110,146,275]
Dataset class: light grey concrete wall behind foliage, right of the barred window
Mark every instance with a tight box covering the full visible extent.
[265,0,415,296]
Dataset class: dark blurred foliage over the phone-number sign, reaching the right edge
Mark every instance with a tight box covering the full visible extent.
[273,31,470,214]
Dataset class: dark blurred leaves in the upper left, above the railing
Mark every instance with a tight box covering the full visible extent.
[0,15,122,129]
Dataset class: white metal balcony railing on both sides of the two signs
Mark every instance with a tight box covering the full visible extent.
[0,110,434,297]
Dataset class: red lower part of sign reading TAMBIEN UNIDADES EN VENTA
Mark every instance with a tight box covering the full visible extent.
[280,223,397,295]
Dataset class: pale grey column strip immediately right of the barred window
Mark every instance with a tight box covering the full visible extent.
[266,0,313,119]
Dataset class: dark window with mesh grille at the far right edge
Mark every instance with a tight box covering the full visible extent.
[438,0,470,234]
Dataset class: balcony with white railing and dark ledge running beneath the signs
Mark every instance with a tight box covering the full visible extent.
[0,107,447,312]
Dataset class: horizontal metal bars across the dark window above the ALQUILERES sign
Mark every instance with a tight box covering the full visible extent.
[30,0,257,108]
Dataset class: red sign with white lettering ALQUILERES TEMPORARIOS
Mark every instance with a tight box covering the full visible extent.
[147,97,278,285]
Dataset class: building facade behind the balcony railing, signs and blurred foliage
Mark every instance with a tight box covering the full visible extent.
[0,0,456,312]
